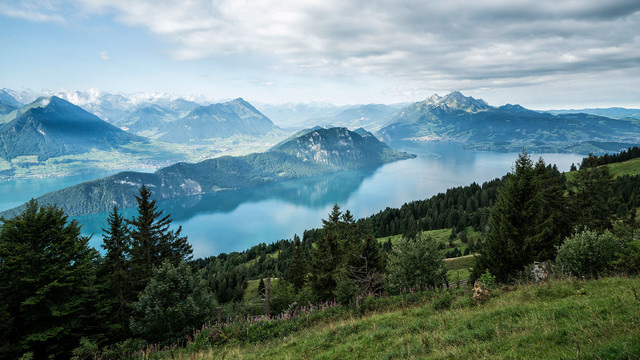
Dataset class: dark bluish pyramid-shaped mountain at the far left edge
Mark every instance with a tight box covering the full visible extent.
[0,96,146,160]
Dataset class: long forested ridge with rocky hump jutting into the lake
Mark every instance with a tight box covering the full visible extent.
[4,128,414,216]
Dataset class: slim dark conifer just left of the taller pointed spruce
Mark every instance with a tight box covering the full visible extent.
[100,206,137,339]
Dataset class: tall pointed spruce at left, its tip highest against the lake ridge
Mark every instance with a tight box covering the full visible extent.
[127,185,193,291]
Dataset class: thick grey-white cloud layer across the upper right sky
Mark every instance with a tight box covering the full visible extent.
[0,0,640,95]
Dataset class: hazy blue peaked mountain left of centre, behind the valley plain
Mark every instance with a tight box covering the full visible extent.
[159,98,275,144]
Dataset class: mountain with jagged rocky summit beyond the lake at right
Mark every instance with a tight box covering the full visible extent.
[378,92,640,150]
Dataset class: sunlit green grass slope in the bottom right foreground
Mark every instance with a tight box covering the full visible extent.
[166,277,640,359]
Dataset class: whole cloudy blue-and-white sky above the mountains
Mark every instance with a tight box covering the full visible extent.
[0,0,640,109]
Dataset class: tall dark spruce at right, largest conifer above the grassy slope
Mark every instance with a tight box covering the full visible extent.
[472,151,544,282]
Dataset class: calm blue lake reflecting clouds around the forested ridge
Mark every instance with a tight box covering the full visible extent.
[0,142,584,257]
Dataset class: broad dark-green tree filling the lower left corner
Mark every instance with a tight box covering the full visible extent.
[0,200,101,359]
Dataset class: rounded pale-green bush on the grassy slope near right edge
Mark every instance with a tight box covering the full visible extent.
[556,230,616,278]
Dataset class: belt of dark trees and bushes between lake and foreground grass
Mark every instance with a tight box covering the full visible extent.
[0,146,640,359]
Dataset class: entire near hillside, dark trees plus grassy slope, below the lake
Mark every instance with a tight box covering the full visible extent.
[0,149,640,359]
